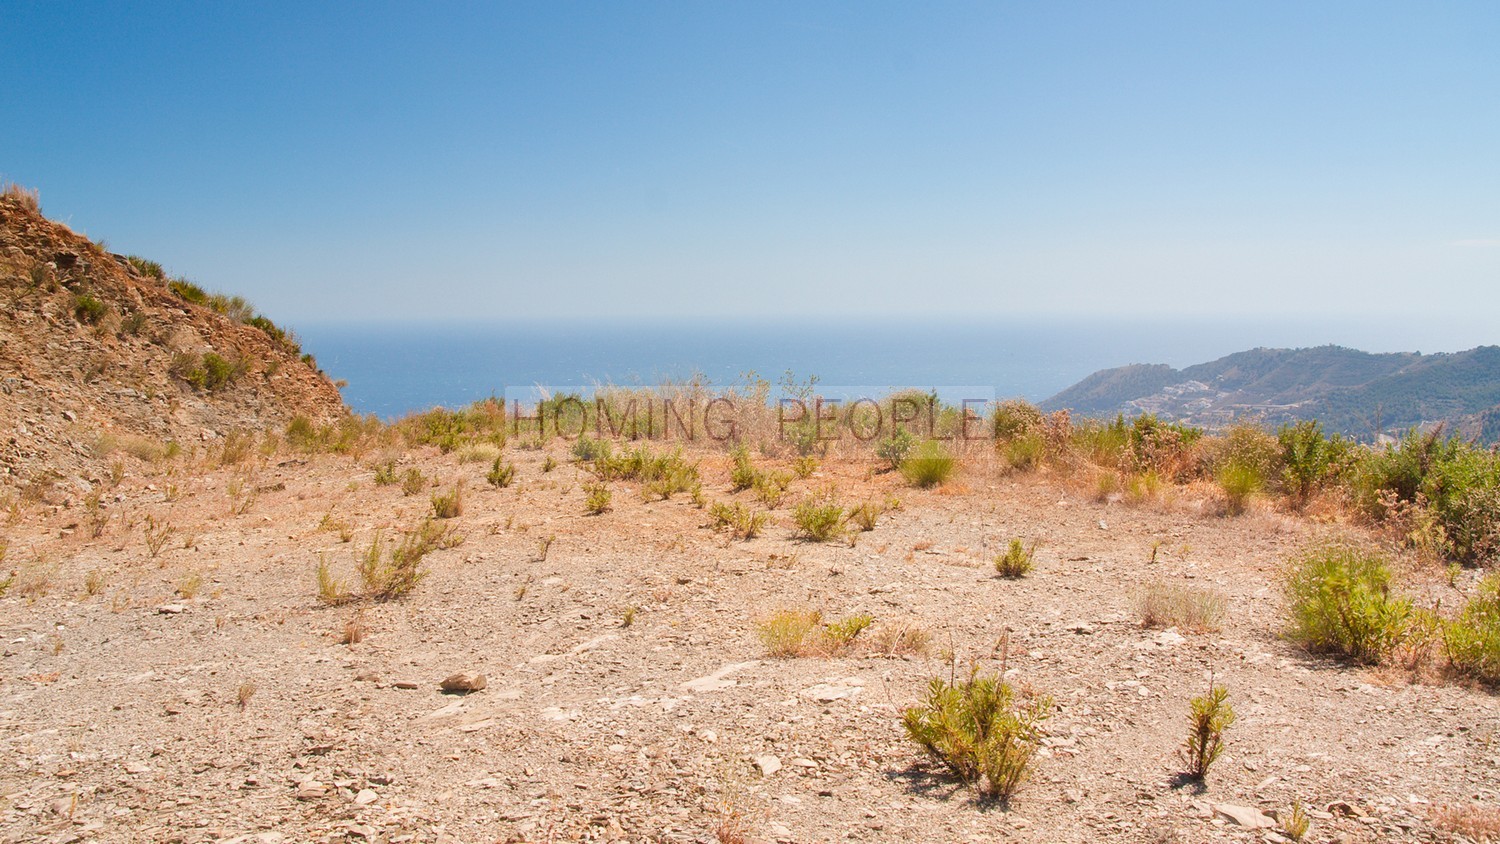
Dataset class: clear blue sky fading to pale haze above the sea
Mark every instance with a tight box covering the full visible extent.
[0,0,1500,328]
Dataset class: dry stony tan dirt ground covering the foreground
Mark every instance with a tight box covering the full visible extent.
[0,444,1500,843]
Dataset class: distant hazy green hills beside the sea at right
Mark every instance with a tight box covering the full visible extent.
[1043,346,1500,442]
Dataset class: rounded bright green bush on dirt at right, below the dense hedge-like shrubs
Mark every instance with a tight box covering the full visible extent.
[1286,543,1412,664]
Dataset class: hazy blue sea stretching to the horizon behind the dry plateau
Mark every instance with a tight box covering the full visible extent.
[297,319,1500,418]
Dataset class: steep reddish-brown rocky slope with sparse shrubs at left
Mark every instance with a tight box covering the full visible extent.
[0,187,347,492]
